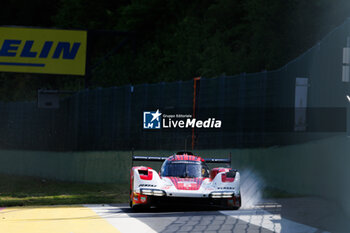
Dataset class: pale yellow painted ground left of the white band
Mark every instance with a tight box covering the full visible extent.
[0,206,120,233]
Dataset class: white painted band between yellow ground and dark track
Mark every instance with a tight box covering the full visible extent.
[84,205,156,233]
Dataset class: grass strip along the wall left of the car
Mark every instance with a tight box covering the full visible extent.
[0,175,129,207]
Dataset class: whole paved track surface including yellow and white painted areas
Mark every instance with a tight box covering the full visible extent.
[0,198,349,233]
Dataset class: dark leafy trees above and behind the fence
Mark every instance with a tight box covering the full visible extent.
[0,0,350,101]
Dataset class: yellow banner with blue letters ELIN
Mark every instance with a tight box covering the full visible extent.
[0,27,87,75]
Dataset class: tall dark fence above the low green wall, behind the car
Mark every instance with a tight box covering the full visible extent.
[0,20,350,151]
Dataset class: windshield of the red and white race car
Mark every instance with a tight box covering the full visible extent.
[161,161,209,178]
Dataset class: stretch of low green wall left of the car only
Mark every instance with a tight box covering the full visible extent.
[0,150,131,183]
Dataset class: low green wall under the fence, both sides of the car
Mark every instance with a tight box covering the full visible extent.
[0,136,350,216]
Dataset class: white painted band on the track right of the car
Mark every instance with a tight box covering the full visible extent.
[219,209,329,233]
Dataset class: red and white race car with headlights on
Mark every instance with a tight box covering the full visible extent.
[130,152,241,210]
